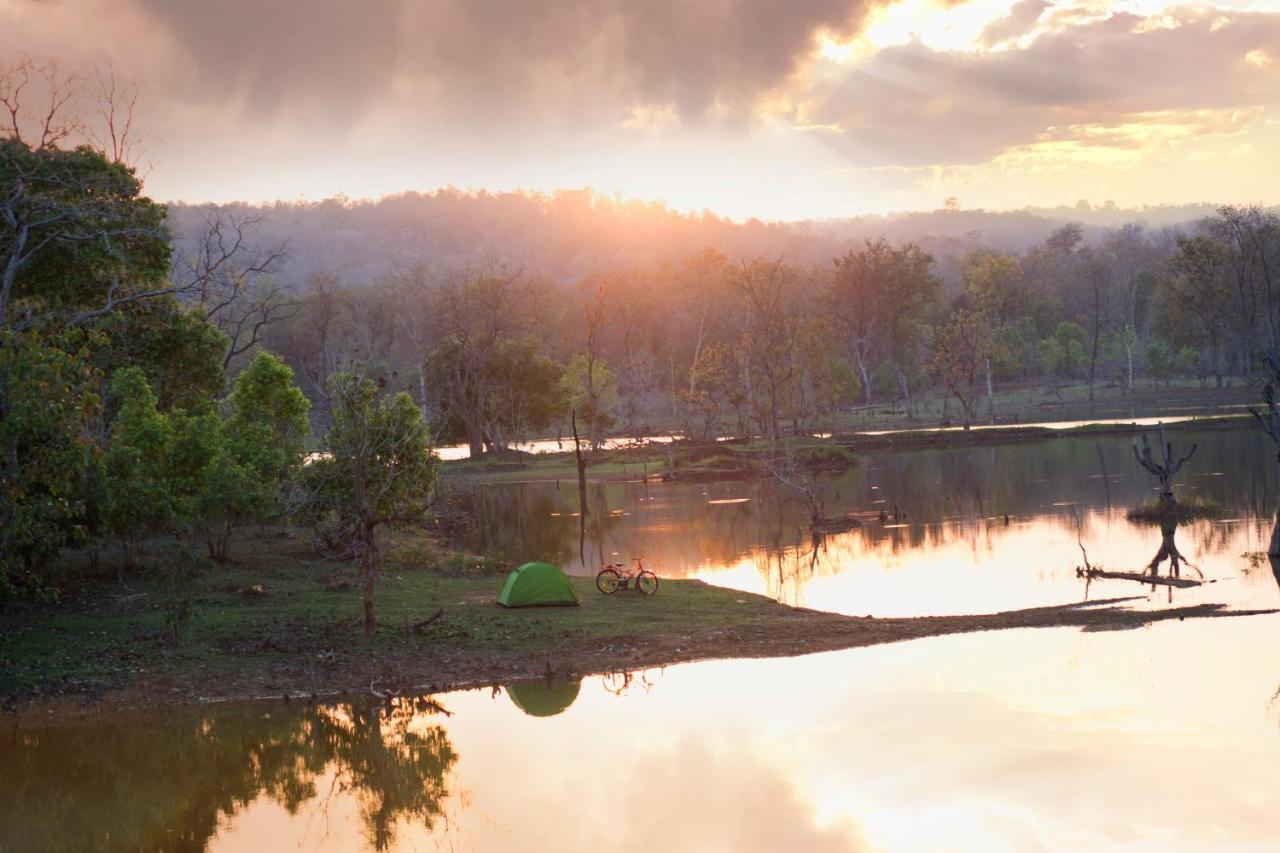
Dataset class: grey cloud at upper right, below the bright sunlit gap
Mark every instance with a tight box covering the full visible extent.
[804,13,1280,165]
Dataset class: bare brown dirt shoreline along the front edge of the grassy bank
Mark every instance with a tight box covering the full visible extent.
[15,594,1280,722]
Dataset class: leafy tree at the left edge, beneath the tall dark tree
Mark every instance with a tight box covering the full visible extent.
[0,332,99,596]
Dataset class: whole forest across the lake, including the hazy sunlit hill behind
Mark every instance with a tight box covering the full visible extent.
[197,192,1280,455]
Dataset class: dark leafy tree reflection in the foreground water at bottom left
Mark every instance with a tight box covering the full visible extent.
[0,699,457,850]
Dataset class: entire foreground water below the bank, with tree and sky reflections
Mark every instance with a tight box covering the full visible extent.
[0,617,1280,852]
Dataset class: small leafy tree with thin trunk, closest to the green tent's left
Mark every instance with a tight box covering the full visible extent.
[294,373,438,637]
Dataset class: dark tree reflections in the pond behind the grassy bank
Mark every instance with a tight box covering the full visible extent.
[484,430,1272,576]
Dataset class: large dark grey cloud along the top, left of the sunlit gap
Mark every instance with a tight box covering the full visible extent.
[127,0,865,120]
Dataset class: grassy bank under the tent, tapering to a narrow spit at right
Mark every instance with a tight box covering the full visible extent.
[0,529,1274,710]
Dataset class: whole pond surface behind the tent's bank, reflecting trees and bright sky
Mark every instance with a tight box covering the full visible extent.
[479,429,1274,616]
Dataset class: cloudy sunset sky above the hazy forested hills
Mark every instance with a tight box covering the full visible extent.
[0,0,1280,220]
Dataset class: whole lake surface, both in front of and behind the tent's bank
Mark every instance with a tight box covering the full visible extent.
[0,429,1280,850]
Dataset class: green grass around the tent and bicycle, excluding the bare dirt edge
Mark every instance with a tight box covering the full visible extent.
[0,528,781,697]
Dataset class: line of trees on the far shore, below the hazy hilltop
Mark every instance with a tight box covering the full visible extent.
[247,199,1280,445]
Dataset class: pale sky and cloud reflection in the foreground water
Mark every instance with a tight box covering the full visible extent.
[197,607,1280,850]
